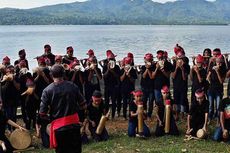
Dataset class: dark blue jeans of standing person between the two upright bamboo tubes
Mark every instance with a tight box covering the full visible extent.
[142,89,154,117]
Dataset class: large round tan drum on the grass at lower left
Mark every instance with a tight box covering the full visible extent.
[9,129,32,150]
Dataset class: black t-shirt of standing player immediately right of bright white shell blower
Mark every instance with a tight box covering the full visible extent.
[121,68,137,93]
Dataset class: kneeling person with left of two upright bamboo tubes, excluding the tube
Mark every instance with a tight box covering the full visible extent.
[128,90,150,137]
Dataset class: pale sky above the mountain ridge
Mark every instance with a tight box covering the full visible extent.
[0,0,216,9]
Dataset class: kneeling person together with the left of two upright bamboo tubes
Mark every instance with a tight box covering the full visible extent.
[128,90,150,137]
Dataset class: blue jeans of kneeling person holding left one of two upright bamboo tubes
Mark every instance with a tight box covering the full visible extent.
[128,121,150,137]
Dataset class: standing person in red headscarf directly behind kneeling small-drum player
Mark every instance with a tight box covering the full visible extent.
[190,54,208,103]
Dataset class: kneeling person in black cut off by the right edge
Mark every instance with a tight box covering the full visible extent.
[213,96,230,141]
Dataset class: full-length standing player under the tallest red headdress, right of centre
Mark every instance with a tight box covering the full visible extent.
[172,50,190,120]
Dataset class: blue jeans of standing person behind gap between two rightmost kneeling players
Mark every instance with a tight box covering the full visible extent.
[208,91,222,119]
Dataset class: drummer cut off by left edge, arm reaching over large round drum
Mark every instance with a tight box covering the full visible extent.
[0,99,26,153]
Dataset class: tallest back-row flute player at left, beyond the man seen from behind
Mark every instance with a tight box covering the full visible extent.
[38,44,55,66]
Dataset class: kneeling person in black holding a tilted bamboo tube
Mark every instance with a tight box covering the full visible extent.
[88,90,109,142]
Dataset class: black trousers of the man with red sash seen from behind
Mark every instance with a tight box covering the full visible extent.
[55,126,82,153]
